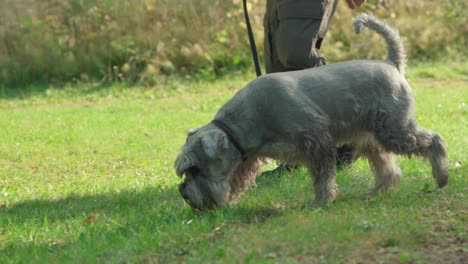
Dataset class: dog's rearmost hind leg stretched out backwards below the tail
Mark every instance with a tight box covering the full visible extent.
[376,121,449,188]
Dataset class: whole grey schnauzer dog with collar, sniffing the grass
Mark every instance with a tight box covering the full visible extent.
[175,14,448,210]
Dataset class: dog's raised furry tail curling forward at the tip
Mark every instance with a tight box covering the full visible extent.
[353,14,406,75]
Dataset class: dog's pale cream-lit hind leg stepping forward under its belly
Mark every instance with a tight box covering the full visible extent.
[359,144,401,197]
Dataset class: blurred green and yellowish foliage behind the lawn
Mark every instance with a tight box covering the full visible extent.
[0,0,468,87]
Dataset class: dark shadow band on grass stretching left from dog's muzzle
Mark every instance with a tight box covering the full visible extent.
[0,187,288,225]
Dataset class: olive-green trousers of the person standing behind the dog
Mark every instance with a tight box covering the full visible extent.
[263,0,328,73]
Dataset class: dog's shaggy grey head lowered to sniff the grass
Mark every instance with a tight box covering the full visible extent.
[175,124,260,210]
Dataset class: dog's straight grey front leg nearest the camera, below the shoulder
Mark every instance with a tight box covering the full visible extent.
[306,135,338,208]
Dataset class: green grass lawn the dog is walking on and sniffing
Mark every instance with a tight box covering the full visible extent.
[0,64,468,263]
